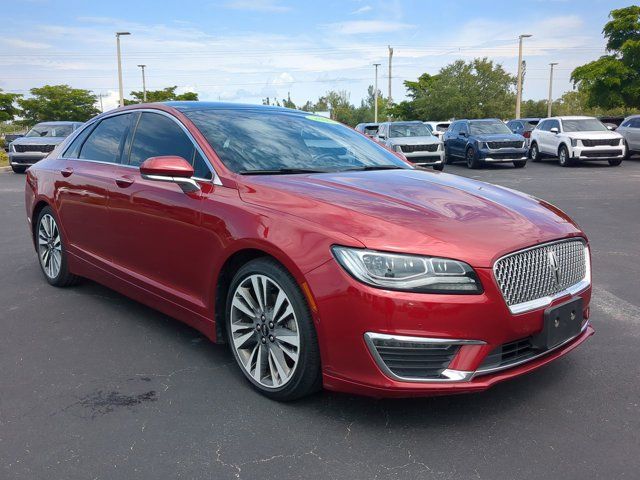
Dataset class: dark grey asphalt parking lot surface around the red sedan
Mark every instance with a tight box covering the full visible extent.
[0,160,640,480]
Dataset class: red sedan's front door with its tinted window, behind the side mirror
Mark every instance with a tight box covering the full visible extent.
[109,111,215,308]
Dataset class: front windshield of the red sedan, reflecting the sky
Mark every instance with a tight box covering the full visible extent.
[184,109,411,174]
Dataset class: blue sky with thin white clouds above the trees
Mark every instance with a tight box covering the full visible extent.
[0,0,631,110]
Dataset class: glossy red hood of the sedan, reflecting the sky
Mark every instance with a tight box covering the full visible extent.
[239,170,581,267]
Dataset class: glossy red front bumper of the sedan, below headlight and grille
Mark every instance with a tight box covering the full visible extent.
[307,260,594,397]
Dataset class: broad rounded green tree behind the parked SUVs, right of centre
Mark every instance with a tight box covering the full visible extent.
[394,58,516,120]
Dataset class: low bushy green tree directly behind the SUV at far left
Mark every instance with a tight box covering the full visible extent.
[18,85,99,125]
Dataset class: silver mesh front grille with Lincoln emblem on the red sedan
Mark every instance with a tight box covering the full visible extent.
[493,240,587,307]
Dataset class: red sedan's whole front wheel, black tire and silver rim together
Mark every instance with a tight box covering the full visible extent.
[225,257,322,401]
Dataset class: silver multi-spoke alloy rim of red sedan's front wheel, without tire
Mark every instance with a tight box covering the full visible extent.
[230,274,300,389]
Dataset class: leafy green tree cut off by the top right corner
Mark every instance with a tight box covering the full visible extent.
[571,5,640,109]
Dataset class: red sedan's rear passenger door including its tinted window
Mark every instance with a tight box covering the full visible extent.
[56,113,131,264]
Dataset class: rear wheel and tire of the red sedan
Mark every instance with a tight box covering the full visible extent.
[34,206,79,287]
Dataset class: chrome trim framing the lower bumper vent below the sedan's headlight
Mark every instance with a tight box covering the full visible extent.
[364,332,486,383]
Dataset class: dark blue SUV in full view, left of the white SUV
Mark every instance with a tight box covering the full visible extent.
[443,118,527,168]
